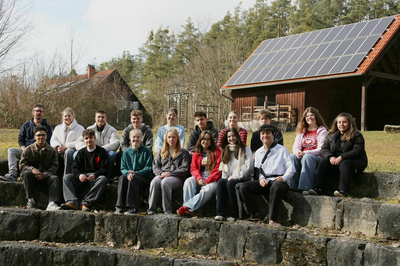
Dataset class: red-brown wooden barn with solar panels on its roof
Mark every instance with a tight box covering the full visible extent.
[221,15,400,130]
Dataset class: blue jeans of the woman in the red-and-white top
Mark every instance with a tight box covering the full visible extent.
[290,154,322,190]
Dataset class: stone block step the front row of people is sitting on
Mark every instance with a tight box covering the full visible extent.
[0,179,400,239]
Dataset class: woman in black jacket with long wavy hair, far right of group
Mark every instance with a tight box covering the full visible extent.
[309,113,368,197]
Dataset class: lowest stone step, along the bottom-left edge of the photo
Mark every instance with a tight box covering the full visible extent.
[0,241,237,266]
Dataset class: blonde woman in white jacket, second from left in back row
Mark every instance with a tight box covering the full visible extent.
[50,107,85,176]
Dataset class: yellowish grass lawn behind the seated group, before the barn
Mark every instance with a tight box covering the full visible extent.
[0,129,400,173]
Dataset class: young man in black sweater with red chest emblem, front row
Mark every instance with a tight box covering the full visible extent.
[61,129,108,211]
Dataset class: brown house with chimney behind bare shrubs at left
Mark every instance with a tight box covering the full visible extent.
[46,65,151,129]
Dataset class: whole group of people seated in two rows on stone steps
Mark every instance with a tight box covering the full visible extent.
[0,104,368,224]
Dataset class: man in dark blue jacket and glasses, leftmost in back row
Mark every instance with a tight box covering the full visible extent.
[0,103,52,182]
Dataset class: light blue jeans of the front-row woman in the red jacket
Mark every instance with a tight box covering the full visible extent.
[183,176,217,211]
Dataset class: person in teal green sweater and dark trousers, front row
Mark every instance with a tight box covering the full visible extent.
[114,129,153,215]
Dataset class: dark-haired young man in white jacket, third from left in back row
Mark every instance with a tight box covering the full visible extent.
[74,110,119,180]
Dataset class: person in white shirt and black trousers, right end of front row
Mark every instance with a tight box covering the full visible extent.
[240,125,296,224]
